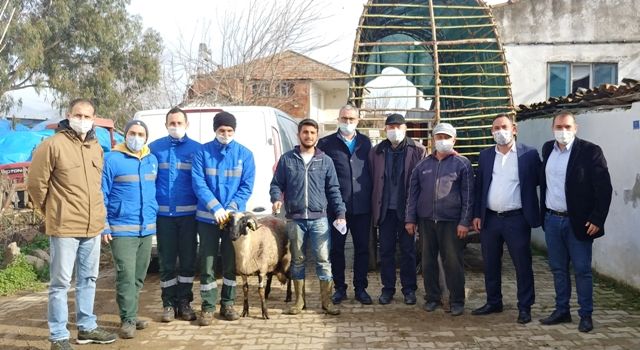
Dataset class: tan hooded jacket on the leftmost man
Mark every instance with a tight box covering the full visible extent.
[27,119,105,237]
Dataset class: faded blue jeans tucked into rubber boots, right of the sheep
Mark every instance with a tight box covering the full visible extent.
[287,218,333,281]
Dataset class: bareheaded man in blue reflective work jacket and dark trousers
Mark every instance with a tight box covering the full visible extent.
[149,107,201,322]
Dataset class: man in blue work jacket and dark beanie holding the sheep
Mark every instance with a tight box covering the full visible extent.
[191,112,256,326]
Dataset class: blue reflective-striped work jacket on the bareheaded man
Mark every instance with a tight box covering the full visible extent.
[149,135,202,216]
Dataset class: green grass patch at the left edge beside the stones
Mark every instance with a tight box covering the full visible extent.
[0,255,48,296]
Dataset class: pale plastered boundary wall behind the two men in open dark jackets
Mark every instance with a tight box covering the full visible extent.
[518,102,640,288]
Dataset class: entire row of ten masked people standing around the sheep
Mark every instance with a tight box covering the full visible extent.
[28,99,612,349]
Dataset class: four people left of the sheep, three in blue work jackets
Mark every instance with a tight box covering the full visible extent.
[27,99,255,350]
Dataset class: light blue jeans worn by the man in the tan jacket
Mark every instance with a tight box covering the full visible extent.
[47,235,100,341]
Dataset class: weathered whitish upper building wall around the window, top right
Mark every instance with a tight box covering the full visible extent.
[493,0,640,105]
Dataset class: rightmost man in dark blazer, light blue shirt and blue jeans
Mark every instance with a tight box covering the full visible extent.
[540,112,613,332]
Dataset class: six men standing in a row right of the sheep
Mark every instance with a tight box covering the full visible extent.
[271,105,612,332]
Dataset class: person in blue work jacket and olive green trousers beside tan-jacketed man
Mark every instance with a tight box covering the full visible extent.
[102,120,158,339]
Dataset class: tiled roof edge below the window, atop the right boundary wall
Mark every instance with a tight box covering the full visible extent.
[516,79,640,120]
